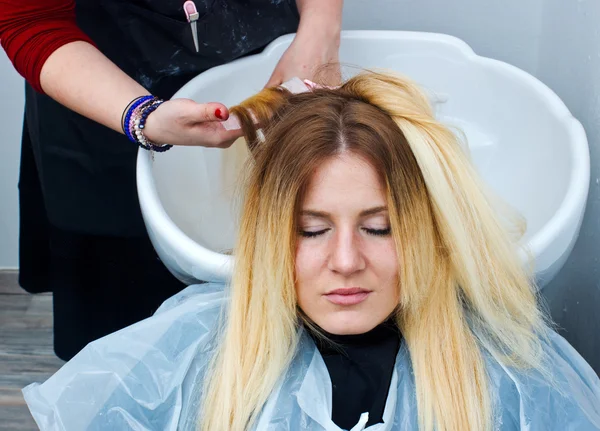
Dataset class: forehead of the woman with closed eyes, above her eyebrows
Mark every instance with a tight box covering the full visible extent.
[302,152,385,211]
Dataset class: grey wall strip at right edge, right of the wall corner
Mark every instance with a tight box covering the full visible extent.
[535,0,600,374]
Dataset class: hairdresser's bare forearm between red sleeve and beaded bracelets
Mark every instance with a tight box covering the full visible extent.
[40,41,148,135]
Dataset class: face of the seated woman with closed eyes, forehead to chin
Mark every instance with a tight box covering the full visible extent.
[296,153,399,335]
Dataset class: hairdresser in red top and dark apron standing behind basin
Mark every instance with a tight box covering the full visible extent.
[0,0,342,360]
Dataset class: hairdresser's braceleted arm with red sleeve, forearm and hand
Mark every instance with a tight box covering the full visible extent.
[0,0,239,147]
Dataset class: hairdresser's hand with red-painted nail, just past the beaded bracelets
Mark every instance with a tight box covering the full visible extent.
[144,99,242,148]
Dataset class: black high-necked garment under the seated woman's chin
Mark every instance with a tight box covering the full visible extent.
[308,319,400,429]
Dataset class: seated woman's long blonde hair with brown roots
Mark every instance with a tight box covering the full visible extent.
[200,72,546,431]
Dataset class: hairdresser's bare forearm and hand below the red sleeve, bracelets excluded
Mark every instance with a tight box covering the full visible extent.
[40,41,241,147]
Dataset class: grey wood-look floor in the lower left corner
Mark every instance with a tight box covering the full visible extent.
[0,271,64,431]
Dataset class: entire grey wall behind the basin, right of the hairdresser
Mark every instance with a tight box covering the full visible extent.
[344,0,600,374]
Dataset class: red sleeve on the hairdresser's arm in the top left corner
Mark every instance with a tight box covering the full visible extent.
[0,0,94,93]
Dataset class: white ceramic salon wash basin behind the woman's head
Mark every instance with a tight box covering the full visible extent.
[137,31,590,286]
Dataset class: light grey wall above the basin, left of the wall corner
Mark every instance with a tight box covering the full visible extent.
[343,0,544,73]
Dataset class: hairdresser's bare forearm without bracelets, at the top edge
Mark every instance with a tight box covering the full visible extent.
[296,0,344,43]
